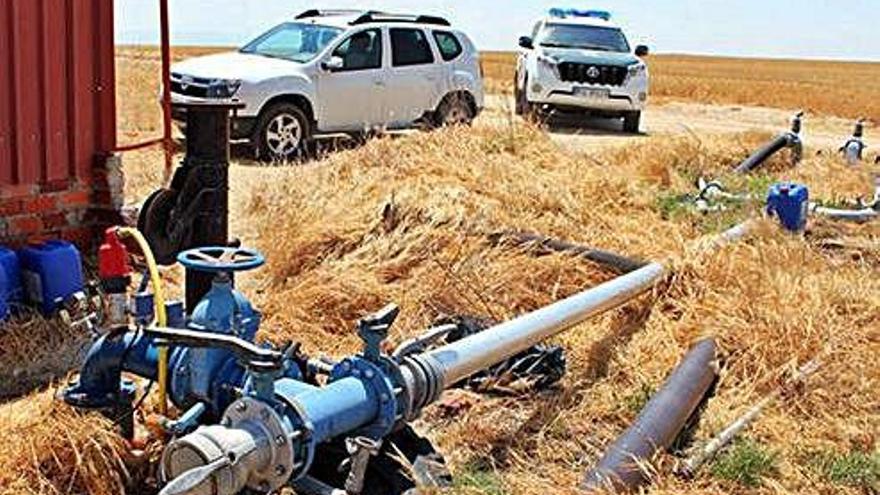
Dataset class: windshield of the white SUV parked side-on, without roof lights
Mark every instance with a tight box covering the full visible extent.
[241,22,343,63]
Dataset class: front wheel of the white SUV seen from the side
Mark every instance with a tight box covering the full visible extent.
[254,103,312,162]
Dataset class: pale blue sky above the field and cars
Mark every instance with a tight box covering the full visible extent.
[114,0,880,61]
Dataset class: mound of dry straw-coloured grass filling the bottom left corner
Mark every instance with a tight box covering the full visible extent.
[0,392,127,495]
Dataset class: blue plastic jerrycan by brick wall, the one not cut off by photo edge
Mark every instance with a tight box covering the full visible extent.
[18,241,84,315]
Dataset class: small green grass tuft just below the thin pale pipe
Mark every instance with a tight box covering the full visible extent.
[710,440,777,487]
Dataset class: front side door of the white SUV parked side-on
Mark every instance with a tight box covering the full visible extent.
[318,28,386,132]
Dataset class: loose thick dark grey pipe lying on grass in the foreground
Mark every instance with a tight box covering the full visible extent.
[582,338,717,492]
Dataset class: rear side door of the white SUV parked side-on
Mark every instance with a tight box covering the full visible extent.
[382,27,448,128]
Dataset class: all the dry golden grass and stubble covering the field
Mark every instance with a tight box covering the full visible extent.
[0,48,880,495]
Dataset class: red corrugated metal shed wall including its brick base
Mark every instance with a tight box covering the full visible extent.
[0,0,116,248]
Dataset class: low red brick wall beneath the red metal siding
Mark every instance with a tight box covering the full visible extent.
[0,155,123,250]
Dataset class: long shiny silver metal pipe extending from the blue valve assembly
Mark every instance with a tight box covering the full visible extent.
[423,263,666,389]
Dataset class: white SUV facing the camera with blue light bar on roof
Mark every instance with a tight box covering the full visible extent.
[515,9,648,133]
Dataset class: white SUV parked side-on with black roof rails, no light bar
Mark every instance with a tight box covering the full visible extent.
[171,10,483,160]
